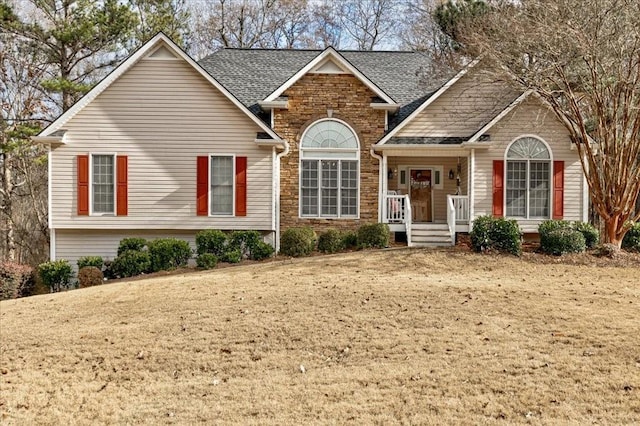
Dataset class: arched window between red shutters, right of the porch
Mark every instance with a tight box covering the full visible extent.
[506,136,551,219]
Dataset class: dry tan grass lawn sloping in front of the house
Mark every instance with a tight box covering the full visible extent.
[0,250,640,424]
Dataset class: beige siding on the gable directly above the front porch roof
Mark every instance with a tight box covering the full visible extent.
[396,70,517,137]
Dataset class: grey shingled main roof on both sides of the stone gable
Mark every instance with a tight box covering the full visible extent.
[199,49,453,127]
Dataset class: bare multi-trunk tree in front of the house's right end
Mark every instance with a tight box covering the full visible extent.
[461,0,640,246]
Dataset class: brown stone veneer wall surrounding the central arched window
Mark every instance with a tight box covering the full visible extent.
[274,74,385,232]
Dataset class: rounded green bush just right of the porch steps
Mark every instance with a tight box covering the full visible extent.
[470,215,522,256]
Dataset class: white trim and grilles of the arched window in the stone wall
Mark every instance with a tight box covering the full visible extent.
[298,118,362,220]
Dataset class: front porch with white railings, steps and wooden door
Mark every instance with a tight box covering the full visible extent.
[381,152,472,246]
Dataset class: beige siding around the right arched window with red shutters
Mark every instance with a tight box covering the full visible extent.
[474,100,583,232]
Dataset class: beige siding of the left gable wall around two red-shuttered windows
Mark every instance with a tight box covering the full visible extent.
[51,59,273,230]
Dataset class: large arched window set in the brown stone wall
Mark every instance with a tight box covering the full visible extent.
[300,119,360,217]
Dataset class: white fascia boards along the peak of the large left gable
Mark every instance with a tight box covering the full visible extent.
[38,32,280,139]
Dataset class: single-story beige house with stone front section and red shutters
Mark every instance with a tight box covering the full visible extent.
[34,34,587,263]
